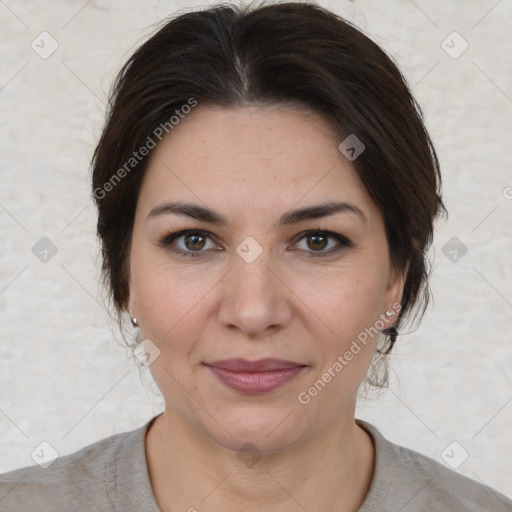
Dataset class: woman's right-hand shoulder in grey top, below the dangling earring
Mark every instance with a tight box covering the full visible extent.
[357,420,512,512]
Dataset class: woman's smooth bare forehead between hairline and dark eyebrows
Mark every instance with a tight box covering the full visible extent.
[139,105,372,221]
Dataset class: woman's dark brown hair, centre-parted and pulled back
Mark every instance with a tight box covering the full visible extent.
[92,2,445,376]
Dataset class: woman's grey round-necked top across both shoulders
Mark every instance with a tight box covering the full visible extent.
[0,416,512,512]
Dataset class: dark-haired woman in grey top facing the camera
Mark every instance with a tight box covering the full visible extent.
[0,3,512,512]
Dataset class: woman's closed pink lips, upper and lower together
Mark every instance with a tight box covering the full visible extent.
[205,358,306,394]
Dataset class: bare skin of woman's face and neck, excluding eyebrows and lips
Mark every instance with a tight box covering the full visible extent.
[128,105,405,512]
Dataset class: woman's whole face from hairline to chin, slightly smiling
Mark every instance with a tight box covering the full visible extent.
[129,105,404,452]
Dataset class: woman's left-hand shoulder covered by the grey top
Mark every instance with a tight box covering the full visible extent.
[0,424,157,512]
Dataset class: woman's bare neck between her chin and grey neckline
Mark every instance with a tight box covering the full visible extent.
[146,408,375,512]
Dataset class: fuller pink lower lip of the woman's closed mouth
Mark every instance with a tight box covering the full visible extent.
[208,366,304,393]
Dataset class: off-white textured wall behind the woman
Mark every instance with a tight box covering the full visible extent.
[0,0,512,496]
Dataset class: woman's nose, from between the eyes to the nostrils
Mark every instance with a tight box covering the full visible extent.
[218,242,293,338]
